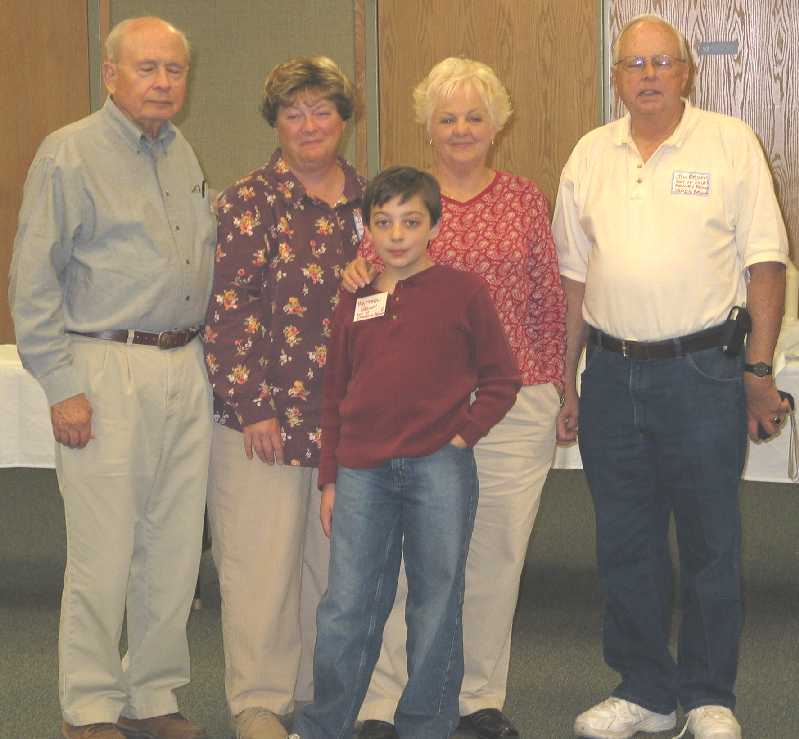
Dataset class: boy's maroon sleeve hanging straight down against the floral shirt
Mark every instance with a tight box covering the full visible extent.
[318,291,355,490]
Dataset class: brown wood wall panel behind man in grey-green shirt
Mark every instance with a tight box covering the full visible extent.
[0,0,89,344]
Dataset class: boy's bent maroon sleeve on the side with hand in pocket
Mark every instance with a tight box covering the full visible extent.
[458,285,522,446]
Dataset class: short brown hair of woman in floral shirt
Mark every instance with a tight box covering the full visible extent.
[261,56,355,128]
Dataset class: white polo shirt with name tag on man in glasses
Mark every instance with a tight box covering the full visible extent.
[552,101,788,341]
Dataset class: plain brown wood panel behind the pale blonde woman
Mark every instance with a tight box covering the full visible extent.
[378,0,600,208]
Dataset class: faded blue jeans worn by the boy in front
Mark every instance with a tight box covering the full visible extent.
[294,444,478,739]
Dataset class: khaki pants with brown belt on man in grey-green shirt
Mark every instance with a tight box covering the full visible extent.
[56,337,211,725]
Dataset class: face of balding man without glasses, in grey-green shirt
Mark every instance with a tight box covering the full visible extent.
[103,20,189,138]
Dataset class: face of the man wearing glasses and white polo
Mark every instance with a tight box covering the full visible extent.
[613,21,690,121]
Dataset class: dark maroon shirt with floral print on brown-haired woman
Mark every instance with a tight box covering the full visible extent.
[204,149,364,467]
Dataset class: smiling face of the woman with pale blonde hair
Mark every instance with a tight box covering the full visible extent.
[430,85,496,167]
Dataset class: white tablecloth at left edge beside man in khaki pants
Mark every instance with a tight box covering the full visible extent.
[0,344,55,467]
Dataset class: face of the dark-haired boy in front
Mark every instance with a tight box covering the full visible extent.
[369,195,438,280]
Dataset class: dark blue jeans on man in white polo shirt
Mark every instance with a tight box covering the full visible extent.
[580,346,746,713]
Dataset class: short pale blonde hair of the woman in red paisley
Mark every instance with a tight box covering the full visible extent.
[413,56,513,132]
